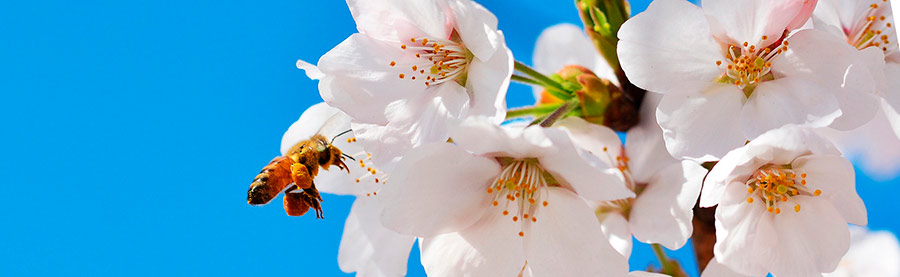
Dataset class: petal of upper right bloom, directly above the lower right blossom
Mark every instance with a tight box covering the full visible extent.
[741,77,841,138]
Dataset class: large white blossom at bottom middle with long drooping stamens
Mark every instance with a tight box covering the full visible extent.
[378,118,634,276]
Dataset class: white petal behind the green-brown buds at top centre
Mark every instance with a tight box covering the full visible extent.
[533,23,619,100]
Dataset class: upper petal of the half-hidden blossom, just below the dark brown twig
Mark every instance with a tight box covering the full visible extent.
[625,93,678,183]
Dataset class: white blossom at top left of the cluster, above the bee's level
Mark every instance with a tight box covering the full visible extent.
[298,0,513,167]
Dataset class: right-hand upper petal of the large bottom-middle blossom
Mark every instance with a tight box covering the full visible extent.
[540,125,634,201]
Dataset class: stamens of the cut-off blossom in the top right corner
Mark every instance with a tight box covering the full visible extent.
[844,0,897,56]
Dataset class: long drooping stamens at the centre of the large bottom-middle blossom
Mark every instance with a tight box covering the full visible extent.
[487,159,553,237]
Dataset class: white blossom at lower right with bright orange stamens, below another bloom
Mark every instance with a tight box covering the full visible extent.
[700,126,867,276]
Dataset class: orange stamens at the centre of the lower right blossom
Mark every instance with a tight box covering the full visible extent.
[747,165,822,214]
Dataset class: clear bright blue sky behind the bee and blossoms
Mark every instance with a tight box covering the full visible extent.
[0,0,900,276]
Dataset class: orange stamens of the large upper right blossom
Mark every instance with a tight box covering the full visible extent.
[716,36,788,90]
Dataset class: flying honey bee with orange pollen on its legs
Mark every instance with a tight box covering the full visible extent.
[247,115,355,218]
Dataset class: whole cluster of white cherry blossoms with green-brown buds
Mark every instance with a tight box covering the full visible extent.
[258,0,900,277]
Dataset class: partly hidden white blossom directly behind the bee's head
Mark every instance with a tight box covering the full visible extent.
[281,103,416,277]
